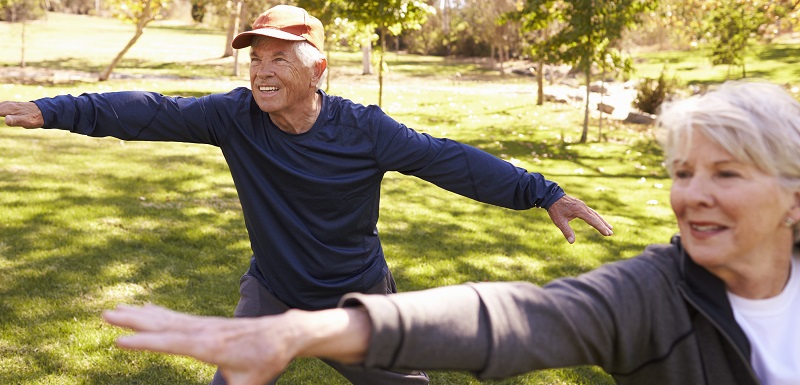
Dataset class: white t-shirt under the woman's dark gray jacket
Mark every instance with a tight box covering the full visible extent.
[728,258,800,385]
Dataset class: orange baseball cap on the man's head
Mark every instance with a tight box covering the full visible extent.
[231,5,325,52]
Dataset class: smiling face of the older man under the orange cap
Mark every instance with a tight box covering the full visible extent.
[250,37,317,116]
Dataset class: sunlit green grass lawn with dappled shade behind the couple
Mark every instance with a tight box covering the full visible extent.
[0,14,792,385]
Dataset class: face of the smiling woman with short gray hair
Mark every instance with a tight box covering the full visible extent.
[670,130,796,280]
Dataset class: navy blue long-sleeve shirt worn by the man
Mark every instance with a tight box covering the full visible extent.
[34,88,564,309]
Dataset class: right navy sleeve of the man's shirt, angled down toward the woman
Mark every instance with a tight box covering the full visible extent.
[373,110,565,210]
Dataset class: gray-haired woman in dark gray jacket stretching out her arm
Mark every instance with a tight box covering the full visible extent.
[105,82,800,385]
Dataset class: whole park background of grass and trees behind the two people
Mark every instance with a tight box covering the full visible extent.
[0,0,800,385]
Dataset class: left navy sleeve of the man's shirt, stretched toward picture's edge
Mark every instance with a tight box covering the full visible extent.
[34,91,247,146]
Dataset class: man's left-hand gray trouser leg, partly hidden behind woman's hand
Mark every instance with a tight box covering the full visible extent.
[210,273,289,385]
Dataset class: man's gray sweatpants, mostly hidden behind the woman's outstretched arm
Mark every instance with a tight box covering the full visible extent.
[210,272,428,385]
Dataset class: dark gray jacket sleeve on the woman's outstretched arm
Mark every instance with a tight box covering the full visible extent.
[341,244,690,379]
